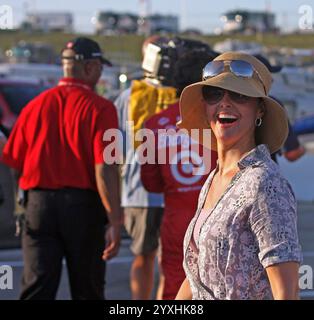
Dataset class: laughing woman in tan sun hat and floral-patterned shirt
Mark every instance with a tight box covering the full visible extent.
[177,52,301,299]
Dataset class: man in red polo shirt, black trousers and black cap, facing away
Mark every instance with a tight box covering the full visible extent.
[3,38,121,299]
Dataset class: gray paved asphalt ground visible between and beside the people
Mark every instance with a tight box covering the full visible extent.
[0,202,314,300]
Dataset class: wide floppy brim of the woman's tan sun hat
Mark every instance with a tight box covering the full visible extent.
[177,73,288,153]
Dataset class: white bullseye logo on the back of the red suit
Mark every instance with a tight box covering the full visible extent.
[170,150,205,185]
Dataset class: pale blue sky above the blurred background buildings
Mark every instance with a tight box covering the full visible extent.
[4,0,314,33]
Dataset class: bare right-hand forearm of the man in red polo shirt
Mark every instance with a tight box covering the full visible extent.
[95,164,122,260]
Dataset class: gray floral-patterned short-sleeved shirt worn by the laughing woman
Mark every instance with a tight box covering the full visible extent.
[183,145,302,300]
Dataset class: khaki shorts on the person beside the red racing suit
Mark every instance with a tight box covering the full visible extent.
[124,207,164,255]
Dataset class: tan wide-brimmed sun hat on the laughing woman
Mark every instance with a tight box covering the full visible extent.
[177,52,289,153]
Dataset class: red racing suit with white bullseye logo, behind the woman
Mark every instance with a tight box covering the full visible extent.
[141,103,217,299]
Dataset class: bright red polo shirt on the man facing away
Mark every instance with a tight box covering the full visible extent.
[3,78,118,190]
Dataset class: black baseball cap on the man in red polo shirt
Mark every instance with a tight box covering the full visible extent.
[61,37,112,67]
